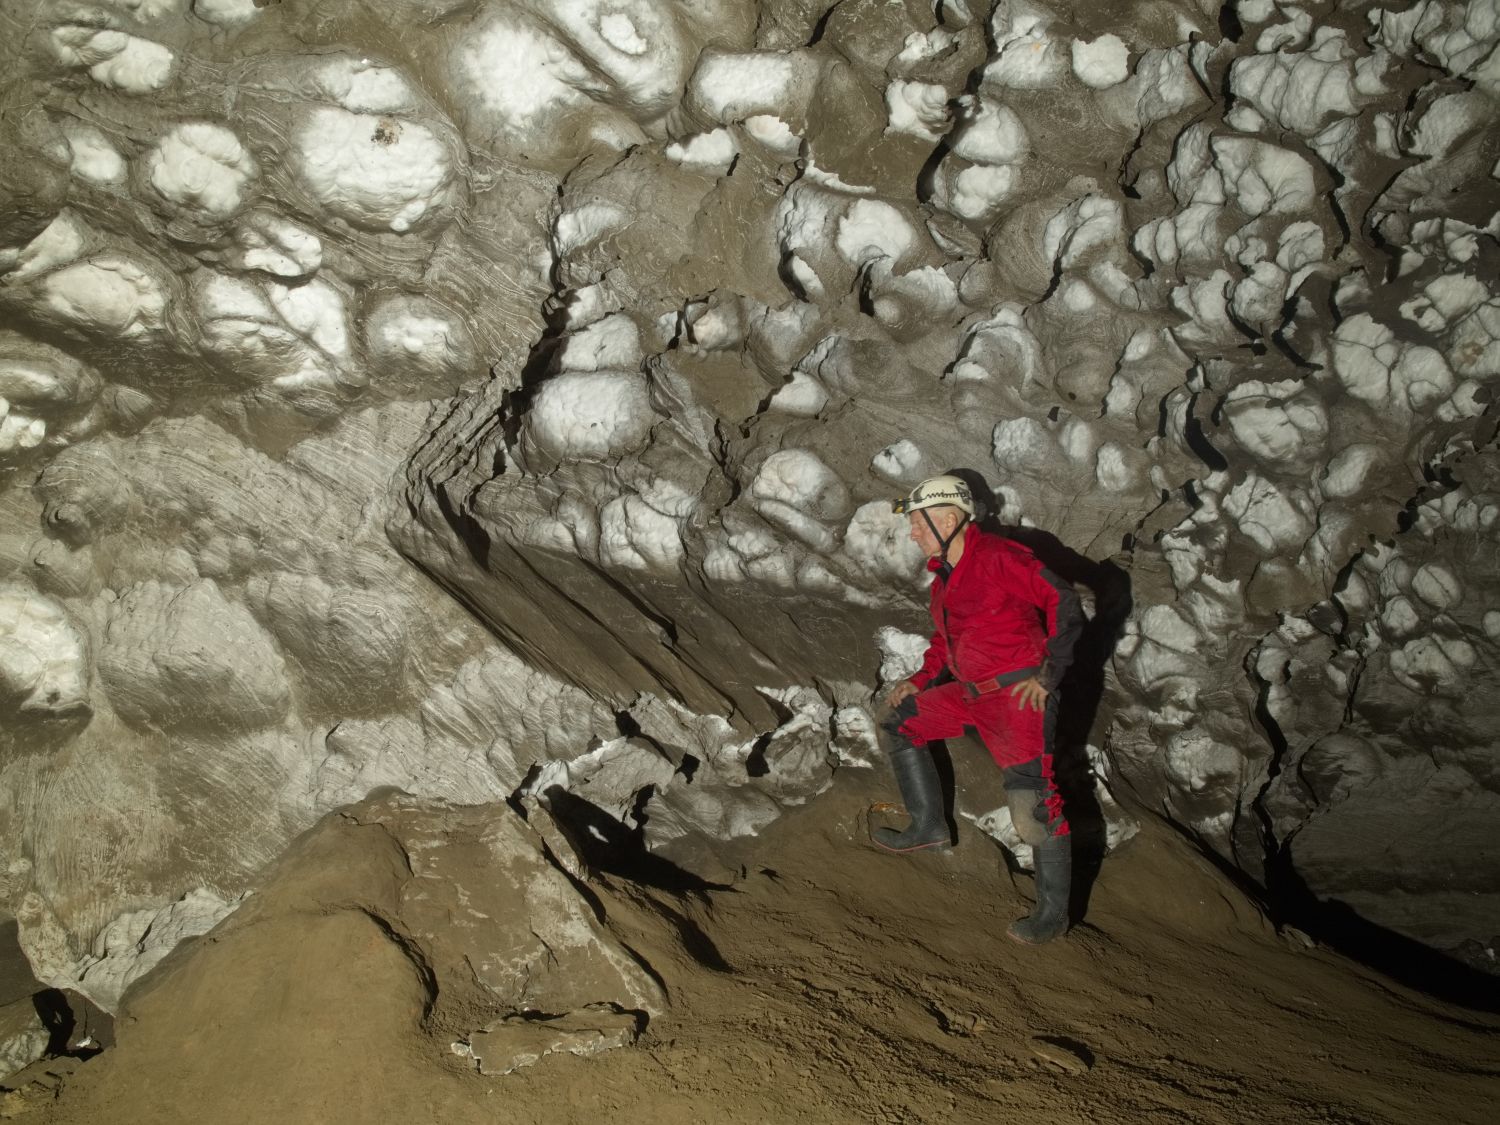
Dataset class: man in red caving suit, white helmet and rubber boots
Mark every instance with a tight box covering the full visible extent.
[873,476,1083,945]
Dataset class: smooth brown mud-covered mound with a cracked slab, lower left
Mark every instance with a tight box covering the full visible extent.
[36,794,668,1121]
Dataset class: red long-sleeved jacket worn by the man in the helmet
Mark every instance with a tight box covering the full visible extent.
[912,525,1083,692]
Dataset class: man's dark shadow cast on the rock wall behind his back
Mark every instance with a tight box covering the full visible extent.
[948,468,1133,923]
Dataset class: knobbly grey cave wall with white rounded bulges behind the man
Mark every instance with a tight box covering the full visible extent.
[0,0,1500,1002]
